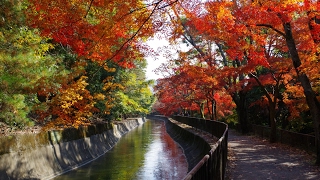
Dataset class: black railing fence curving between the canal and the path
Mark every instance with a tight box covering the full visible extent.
[172,116,228,180]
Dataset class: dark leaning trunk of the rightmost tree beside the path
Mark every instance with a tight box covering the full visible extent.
[283,22,320,164]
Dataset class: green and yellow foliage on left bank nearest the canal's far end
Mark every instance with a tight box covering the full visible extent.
[86,60,154,119]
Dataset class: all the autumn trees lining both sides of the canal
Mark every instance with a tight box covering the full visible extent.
[0,0,320,164]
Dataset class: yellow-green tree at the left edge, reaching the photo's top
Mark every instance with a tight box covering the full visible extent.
[0,1,61,127]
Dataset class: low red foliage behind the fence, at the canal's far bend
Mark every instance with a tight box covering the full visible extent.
[155,65,234,118]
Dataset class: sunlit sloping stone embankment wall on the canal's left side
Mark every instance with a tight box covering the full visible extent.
[0,118,145,180]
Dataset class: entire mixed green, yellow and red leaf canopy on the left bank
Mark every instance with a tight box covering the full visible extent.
[0,0,160,127]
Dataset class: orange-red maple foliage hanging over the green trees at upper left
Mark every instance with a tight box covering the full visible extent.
[28,0,155,67]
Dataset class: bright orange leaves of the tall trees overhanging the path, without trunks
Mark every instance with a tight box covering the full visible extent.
[187,1,320,120]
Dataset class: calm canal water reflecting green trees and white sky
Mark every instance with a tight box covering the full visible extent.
[54,120,188,180]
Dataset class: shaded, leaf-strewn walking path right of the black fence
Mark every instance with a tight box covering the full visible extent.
[226,130,320,180]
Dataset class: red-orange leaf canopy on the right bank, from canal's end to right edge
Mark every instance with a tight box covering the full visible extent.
[151,0,320,135]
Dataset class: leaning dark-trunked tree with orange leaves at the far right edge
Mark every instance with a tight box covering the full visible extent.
[224,1,320,164]
